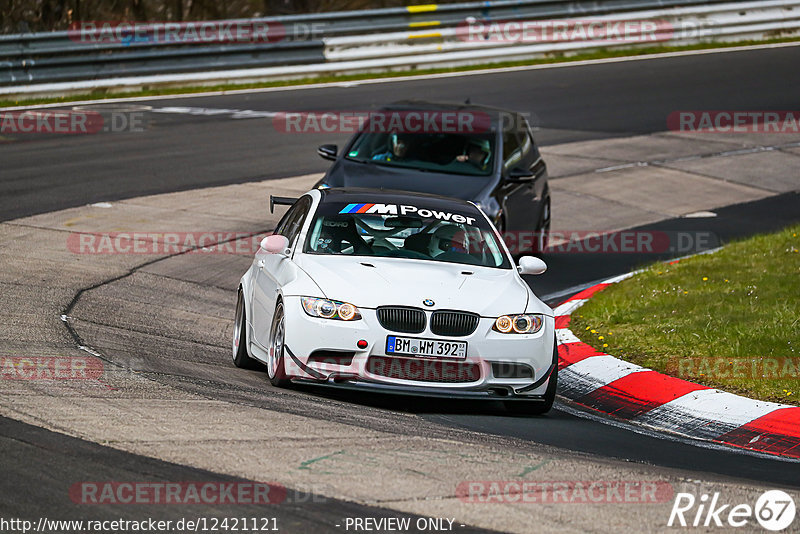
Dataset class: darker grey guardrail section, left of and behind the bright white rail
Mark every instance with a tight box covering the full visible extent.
[0,0,744,85]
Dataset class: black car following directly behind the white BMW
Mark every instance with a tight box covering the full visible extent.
[316,100,550,255]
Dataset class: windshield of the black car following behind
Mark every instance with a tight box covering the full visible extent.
[345,132,495,176]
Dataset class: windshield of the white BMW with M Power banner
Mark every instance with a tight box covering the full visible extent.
[303,199,511,269]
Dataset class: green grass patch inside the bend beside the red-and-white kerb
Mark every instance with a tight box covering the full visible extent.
[571,225,800,405]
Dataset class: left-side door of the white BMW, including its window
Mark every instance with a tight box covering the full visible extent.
[253,196,311,348]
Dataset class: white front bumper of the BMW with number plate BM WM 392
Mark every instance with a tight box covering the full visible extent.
[284,297,555,400]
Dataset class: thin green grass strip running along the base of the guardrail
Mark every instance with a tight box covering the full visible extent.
[0,37,800,108]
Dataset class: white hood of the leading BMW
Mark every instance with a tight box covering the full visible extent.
[295,254,529,317]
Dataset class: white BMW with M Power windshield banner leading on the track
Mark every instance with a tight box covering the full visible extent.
[233,189,558,414]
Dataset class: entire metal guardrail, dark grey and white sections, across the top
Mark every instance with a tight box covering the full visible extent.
[0,0,800,95]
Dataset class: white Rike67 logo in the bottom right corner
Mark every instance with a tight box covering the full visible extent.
[667,490,797,532]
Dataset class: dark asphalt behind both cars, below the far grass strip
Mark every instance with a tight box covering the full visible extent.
[0,46,800,220]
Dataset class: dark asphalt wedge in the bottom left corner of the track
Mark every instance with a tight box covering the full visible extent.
[0,417,490,533]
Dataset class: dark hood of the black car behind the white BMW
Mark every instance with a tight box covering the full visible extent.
[323,159,492,200]
